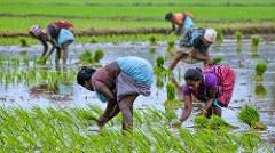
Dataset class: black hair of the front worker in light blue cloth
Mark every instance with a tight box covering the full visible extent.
[77,66,96,86]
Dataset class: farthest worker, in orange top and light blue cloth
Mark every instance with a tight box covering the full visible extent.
[165,13,195,34]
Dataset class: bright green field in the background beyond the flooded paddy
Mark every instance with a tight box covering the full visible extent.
[0,0,275,33]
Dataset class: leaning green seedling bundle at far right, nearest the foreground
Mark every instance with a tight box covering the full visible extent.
[238,105,266,129]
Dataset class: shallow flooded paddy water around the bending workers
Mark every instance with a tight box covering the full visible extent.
[0,40,275,146]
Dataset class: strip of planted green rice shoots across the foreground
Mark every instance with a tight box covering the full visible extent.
[0,106,267,153]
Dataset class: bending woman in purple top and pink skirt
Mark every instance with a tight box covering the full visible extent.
[175,65,236,124]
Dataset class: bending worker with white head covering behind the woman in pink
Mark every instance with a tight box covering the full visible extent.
[170,29,217,70]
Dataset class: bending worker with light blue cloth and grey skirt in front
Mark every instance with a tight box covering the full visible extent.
[77,56,153,130]
